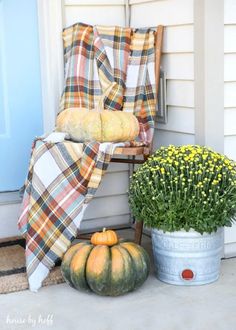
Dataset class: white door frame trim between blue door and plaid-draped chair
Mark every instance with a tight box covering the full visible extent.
[37,0,64,133]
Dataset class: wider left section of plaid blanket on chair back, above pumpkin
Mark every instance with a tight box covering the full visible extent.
[60,23,131,111]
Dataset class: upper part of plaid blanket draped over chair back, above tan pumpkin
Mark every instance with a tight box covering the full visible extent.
[60,23,156,144]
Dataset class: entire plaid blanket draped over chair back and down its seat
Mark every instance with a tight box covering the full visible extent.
[18,24,155,291]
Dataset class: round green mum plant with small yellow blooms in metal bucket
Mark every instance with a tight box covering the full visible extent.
[129,145,236,233]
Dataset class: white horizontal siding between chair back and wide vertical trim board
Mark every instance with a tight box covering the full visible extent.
[130,0,195,147]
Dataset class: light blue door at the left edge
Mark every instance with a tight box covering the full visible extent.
[0,0,43,192]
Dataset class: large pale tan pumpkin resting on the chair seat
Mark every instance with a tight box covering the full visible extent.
[56,108,139,142]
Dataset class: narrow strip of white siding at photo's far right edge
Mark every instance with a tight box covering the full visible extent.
[224,0,236,248]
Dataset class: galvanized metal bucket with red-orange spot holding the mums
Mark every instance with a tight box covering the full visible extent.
[152,228,224,285]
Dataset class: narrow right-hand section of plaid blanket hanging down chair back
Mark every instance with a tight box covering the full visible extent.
[123,29,156,144]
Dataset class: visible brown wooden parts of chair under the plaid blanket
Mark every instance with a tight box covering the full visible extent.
[78,25,164,244]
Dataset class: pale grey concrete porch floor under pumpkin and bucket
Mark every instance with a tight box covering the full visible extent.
[0,230,236,330]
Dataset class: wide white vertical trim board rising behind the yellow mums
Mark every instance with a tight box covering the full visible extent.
[194,0,224,153]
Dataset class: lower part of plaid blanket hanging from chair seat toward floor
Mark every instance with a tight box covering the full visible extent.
[18,139,114,291]
